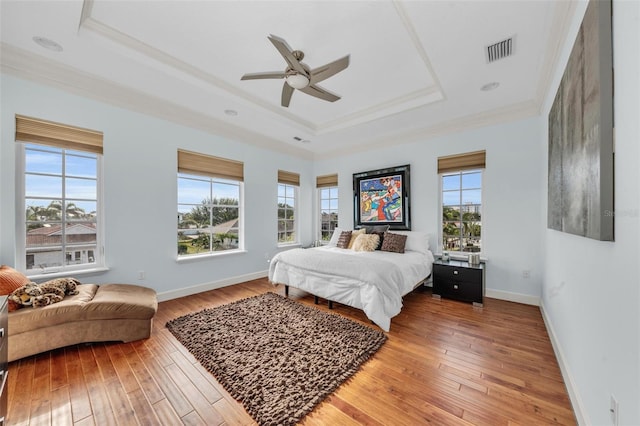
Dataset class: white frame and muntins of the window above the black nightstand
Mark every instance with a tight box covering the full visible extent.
[438,167,485,258]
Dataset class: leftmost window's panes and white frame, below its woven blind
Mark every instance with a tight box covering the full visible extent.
[22,144,101,272]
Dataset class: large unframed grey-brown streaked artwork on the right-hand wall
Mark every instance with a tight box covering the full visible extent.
[547,0,614,241]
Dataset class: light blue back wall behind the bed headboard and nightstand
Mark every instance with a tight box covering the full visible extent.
[315,118,546,304]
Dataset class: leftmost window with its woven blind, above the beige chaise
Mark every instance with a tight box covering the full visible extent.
[16,116,104,273]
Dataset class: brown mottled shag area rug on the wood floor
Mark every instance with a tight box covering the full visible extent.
[167,293,387,425]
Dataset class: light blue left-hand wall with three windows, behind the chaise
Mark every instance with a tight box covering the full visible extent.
[0,75,315,294]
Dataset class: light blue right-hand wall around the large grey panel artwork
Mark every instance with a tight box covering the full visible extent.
[540,1,640,425]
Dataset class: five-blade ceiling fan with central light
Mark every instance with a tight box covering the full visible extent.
[240,34,349,107]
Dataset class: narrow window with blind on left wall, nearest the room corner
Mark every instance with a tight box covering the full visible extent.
[278,170,300,244]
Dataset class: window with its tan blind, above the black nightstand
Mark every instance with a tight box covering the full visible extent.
[438,151,485,253]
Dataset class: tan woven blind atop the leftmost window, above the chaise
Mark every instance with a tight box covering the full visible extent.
[16,114,103,154]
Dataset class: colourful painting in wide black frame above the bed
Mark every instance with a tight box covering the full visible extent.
[353,164,411,230]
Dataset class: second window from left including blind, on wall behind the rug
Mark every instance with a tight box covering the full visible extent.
[178,150,244,257]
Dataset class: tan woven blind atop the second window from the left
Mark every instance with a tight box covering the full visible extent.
[178,149,244,182]
